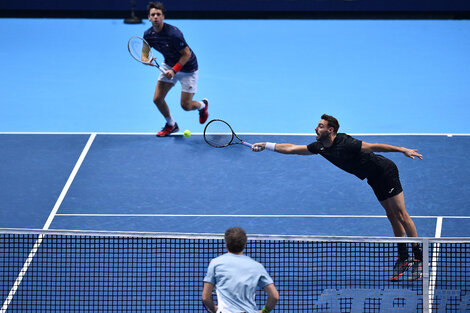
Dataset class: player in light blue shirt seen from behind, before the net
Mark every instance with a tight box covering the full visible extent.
[202,227,279,313]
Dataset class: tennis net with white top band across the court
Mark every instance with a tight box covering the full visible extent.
[0,229,470,313]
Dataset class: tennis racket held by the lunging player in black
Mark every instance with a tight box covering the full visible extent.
[204,119,252,148]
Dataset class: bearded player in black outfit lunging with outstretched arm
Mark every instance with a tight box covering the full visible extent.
[252,114,423,281]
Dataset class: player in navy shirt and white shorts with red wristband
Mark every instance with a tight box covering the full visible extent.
[144,2,209,137]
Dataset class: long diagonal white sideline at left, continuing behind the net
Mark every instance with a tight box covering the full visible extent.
[0,133,96,313]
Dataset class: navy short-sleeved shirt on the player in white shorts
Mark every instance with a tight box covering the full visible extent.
[144,23,198,73]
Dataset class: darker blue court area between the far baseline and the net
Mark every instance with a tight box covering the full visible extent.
[0,134,470,237]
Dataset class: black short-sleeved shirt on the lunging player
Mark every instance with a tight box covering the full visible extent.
[307,133,392,179]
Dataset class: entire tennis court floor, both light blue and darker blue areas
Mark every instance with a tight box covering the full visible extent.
[0,19,470,313]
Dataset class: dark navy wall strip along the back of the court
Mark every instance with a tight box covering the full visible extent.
[0,0,470,18]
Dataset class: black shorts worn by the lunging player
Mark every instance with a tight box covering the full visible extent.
[367,158,403,201]
